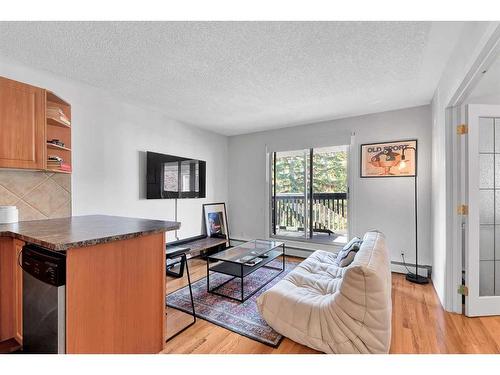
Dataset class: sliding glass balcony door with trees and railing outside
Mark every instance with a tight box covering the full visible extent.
[270,145,349,244]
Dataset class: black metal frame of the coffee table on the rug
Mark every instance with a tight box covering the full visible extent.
[207,240,285,302]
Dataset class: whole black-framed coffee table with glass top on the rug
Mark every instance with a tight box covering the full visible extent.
[207,240,285,302]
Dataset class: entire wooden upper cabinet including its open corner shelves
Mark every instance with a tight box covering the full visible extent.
[0,77,71,173]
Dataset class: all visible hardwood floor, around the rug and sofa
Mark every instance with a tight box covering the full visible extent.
[162,258,500,354]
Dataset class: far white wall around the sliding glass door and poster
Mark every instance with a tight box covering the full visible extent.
[228,106,432,265]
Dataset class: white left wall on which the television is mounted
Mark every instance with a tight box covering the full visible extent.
[0,57,228,240]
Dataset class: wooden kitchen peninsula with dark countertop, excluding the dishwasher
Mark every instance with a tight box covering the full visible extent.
[0,215,180,353]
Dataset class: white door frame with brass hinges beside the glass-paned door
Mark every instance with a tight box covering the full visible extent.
[445,26,500,314]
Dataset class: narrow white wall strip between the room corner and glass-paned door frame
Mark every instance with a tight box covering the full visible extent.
[431,22,497,312]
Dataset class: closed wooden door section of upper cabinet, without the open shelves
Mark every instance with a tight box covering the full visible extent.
[0,77,46,169]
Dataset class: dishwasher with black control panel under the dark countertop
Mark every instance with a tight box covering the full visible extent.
[21,244,66,354]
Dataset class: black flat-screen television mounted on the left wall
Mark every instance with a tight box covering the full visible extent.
[146,151,206,199]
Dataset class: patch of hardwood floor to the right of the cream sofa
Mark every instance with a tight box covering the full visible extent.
[391,274,500,354]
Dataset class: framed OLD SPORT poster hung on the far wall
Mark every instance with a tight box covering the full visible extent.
[360,139,418,178]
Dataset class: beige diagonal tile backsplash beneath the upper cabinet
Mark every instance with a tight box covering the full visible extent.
[0,169,71,221]
